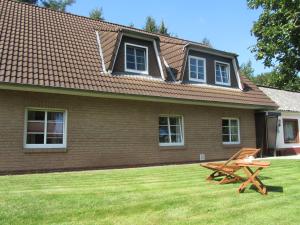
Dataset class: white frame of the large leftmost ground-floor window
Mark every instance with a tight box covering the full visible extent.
[24,108,68,149]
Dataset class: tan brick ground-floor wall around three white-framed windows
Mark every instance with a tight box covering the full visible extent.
[0,90,255,172]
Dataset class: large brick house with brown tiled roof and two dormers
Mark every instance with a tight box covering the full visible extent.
[0,0,277,172]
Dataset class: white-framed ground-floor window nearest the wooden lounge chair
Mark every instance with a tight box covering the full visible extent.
[222,118,240,144]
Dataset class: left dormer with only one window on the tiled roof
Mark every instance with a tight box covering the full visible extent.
[99,29,167,80]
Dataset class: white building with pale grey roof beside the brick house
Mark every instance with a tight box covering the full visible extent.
[259,87,300,155]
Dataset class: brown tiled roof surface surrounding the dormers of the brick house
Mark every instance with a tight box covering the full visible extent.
[0,0,276,107]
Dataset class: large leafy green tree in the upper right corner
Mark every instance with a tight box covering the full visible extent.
[247,0,300,76]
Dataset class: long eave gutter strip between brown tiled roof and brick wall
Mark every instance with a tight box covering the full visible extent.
[0,83,276,110]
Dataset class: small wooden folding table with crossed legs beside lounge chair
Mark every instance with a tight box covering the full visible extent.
[236,160,270,195]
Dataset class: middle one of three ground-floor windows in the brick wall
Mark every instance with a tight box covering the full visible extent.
[159,116,183,146]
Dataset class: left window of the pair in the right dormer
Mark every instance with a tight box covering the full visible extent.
[189,56,206,82]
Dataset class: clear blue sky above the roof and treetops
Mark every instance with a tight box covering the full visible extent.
[67,0,270,74]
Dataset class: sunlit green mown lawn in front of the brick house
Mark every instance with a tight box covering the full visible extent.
[0,160,300,225]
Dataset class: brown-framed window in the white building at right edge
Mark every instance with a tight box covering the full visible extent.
[283,119,298,144]
